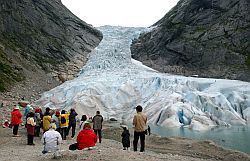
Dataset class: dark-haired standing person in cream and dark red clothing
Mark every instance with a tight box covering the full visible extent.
[26,112,36,145]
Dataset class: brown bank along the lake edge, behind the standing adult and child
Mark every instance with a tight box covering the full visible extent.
[104,123,250,161]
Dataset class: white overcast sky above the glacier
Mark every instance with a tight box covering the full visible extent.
[62,0,179,27]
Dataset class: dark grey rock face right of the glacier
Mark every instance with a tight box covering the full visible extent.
[131,0,250,81]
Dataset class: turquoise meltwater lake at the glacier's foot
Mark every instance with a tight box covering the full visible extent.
[150,125,250,154]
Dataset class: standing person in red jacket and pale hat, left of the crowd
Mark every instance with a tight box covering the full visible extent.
[11,105,22,137]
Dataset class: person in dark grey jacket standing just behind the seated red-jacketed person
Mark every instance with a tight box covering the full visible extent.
[92,111,103,143]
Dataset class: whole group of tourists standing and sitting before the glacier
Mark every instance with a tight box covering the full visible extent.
[9,104,149,155]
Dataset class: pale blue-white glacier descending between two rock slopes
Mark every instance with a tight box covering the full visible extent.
[34,26,250,131]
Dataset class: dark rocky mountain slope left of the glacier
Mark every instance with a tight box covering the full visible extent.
[0,0,102,95]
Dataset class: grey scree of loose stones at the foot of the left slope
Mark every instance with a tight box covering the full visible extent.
[0,70,60,122]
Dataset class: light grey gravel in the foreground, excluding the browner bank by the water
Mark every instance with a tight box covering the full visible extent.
[0,127,215,161]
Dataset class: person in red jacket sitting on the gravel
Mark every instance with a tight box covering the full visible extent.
[69,123,97,150]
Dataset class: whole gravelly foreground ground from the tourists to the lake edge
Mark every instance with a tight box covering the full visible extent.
[0,123,250,161]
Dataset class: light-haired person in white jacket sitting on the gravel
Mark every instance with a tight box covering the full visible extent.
[41,123,62,154]
